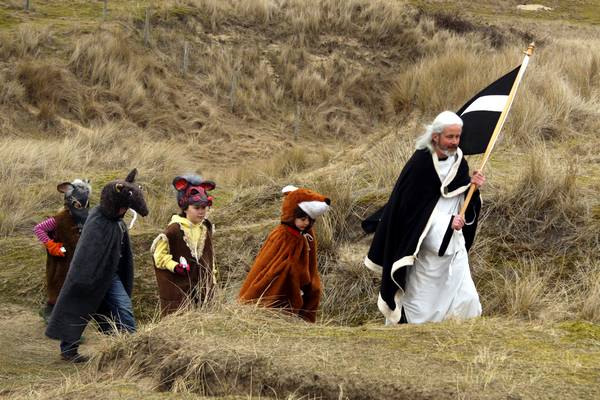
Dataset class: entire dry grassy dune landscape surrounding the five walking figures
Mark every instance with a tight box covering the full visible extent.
[0,0,600,399]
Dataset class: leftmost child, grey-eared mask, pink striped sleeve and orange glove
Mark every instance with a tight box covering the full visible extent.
[33,179,92,323]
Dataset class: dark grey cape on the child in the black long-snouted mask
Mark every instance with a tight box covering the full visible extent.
[46,206,133,342]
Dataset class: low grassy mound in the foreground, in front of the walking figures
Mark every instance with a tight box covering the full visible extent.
[18,306,598,399]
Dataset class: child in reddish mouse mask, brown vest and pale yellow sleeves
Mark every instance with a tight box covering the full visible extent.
[150,175,217,316]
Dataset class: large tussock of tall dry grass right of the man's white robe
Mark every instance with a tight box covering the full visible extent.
[474,148,598,320]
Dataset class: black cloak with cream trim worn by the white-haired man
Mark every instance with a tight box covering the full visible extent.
[363,149,481,322]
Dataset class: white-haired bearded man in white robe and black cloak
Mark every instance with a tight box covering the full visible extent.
[365,111,485,324]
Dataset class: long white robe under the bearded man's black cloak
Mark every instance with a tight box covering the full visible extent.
[402,157,481,324]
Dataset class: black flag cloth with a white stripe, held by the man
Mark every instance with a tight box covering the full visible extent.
[456,65,521,155]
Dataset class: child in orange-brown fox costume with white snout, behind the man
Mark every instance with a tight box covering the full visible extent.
[239,186,331,322]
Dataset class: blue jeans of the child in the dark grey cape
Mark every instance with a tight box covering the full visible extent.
[60,275,136,355]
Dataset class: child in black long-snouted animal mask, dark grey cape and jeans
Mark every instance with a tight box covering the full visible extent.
[46,169,148,362]
